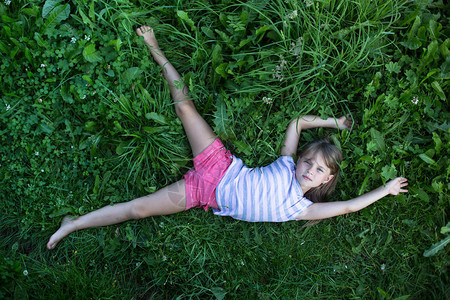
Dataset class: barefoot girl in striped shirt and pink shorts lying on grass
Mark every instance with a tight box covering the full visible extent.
[47,26,408,249]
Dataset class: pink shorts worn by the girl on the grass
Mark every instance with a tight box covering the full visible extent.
[184,138,233,211]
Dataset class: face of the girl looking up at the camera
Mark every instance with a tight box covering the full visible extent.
[295,153,334,193]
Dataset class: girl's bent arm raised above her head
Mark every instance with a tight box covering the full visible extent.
[281,115,353,156]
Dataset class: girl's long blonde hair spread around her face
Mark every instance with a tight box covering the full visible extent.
[299,137,342,227]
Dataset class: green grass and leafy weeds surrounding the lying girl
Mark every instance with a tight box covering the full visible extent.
[0,0,450,299]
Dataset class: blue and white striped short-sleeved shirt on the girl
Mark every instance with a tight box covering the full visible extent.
[213,156,312,222]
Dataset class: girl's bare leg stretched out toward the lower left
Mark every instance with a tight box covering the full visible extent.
[47,179,186,249]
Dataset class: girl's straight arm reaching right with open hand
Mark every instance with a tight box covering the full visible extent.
[297,177,408,220]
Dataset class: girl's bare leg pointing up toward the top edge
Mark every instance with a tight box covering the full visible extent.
[136,26,217,157]
